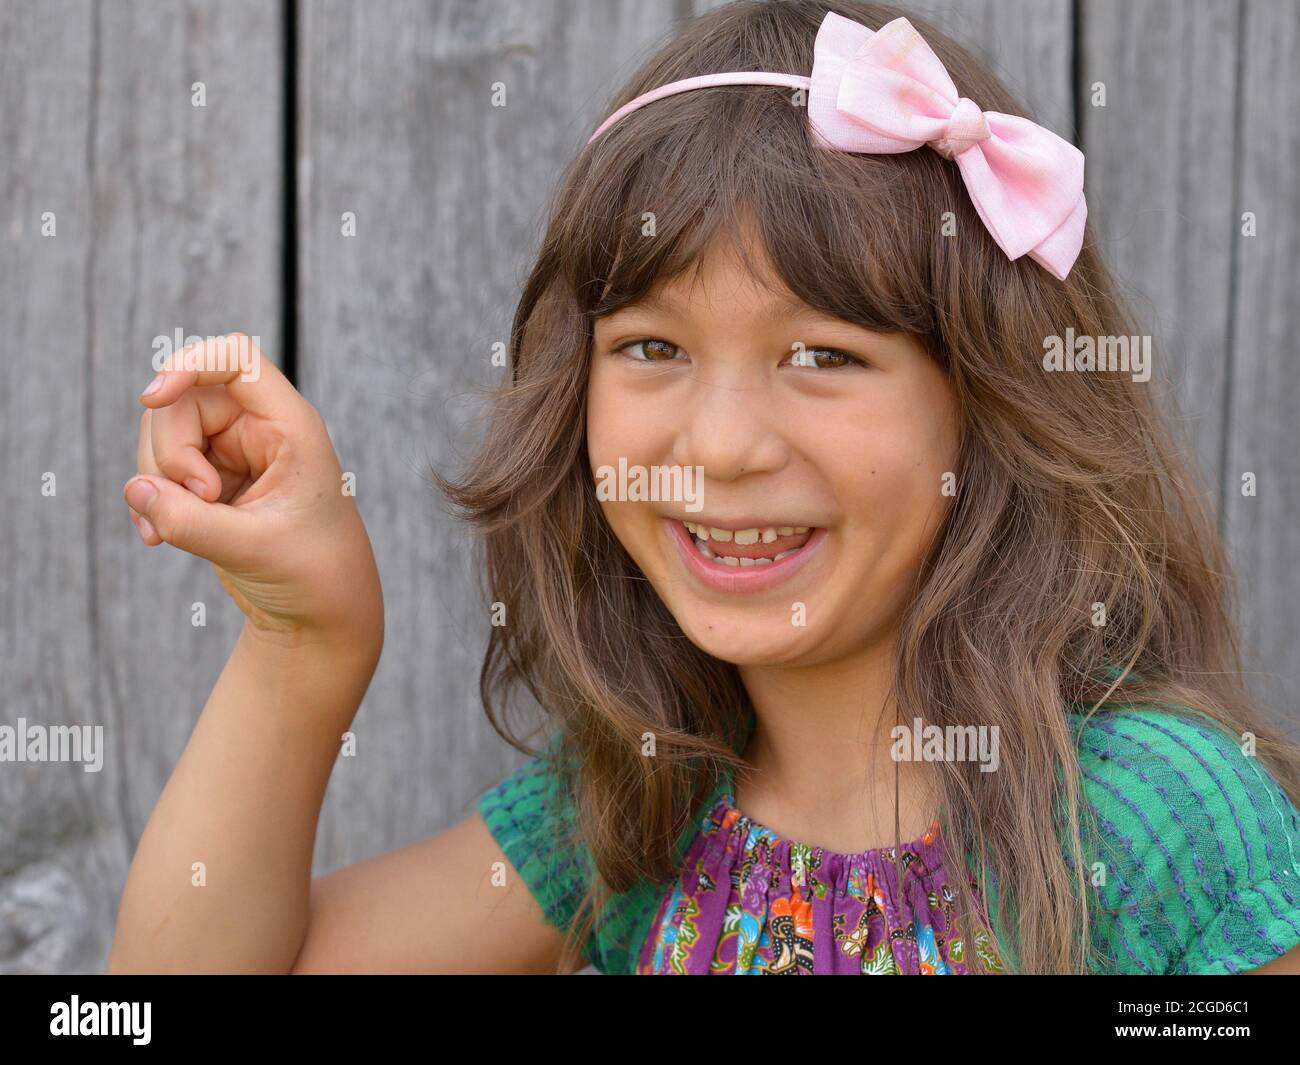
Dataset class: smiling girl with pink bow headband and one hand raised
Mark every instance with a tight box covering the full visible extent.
[109,0,1300,974]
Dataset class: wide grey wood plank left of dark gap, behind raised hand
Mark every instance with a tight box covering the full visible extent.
[0,0,283,971]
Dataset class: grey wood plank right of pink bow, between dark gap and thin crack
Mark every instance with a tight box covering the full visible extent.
[1079,0,1236,506]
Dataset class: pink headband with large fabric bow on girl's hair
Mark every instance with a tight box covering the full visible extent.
[588,12,1088,281]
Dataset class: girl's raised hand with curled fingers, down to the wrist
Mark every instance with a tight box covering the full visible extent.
[124,333,384,638]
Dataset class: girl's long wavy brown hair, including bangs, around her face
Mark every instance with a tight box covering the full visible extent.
[434,0,1300,973]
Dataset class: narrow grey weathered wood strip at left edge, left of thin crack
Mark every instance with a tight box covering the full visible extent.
[0,3,102,973]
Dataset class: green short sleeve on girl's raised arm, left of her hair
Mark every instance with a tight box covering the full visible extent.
[477,733,590,951]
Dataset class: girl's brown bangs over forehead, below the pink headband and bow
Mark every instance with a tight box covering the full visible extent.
[554,86,956,338]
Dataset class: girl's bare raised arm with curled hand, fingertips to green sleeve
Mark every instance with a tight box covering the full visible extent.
[108,334,563,973]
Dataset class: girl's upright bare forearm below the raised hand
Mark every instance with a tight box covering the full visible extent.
[108,622,382,973]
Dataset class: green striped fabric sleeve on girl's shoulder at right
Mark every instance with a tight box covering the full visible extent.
[1075,709,1300,973]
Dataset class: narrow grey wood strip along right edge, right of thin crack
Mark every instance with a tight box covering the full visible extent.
[1216,0,1300,731]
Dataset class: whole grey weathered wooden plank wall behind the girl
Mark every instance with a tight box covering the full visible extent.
[0,0,1300,973]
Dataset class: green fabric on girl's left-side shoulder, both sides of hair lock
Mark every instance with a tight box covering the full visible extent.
[477,732,681,973]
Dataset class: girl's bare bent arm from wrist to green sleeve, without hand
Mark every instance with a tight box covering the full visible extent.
[108,616,574,973]
